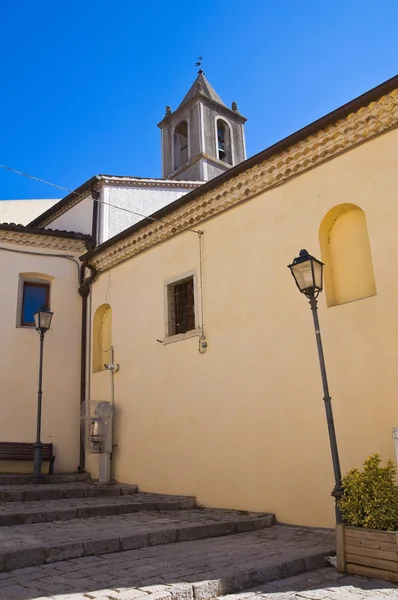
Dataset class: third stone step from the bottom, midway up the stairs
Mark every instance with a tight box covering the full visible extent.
[0,493,196,526]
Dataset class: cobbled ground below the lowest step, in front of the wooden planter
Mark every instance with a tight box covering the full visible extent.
[219,567,398,600]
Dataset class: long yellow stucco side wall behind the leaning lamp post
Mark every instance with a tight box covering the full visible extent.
[89,130,398,526]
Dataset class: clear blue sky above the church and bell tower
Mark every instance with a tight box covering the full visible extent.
[0,0,398,199]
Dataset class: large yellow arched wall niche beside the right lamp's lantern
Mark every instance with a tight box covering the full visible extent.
[319,203,376,306]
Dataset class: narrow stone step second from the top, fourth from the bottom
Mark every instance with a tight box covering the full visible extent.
[0,481,138,502]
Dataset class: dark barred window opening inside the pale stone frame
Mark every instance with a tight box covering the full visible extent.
[167,277,195,336]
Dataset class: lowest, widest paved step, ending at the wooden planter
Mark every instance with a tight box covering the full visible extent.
[0,525,336,600]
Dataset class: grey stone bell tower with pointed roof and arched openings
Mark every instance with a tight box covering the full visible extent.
[158,69,246,181]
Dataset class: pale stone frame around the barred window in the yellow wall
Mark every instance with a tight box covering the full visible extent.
[163,270,201,344]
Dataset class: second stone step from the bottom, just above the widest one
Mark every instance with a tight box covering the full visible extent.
[0,509,275,571]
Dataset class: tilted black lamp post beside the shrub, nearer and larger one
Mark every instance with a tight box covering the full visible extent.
[288,250,343,523]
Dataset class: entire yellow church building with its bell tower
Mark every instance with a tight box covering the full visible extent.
[0,72,398,526]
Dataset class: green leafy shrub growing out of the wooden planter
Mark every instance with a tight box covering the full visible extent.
[339,454,398,531]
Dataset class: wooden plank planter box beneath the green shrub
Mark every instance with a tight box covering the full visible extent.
[336,525,398,583]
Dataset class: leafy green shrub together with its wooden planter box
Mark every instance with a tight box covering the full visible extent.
[336,454,398,582]
